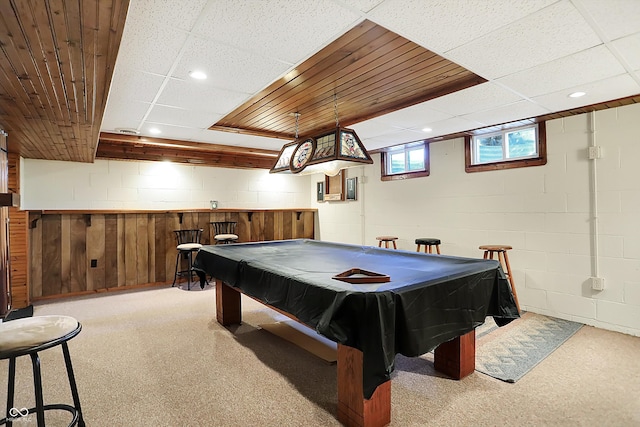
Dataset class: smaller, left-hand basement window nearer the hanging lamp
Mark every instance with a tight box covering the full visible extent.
[381,141,429,181]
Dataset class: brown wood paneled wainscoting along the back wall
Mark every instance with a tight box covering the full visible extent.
[29,209,317,300]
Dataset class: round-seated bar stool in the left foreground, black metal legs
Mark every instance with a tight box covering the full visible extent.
[0,316,85,427]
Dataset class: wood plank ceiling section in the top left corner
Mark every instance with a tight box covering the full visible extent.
[0,0,129,162]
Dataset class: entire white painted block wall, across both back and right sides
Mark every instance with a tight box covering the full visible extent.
[17,105,640,336]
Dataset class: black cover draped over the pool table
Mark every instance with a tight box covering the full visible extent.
[194,239,519,399]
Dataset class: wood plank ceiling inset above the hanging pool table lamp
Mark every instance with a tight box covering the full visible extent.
[210,20,486,139]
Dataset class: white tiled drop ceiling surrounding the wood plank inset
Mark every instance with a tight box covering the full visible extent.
[0,0,640,167]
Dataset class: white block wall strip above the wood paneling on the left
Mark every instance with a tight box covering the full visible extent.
[21,159,311,210]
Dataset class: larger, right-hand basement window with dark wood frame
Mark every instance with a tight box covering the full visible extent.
[465,122,547,172]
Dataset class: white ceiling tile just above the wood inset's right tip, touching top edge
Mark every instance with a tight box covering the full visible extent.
[445,1,601,79]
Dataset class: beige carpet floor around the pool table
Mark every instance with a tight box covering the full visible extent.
[0,286,640,427]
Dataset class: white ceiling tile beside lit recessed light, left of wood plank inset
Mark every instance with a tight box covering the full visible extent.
[172,37,290,93]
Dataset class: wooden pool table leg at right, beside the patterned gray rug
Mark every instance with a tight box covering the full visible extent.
[434,329,476,380]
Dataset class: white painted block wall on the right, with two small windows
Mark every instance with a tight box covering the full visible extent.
[310,105,640,336]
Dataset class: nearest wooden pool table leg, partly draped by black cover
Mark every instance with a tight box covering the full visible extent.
[338,344,391,427]
